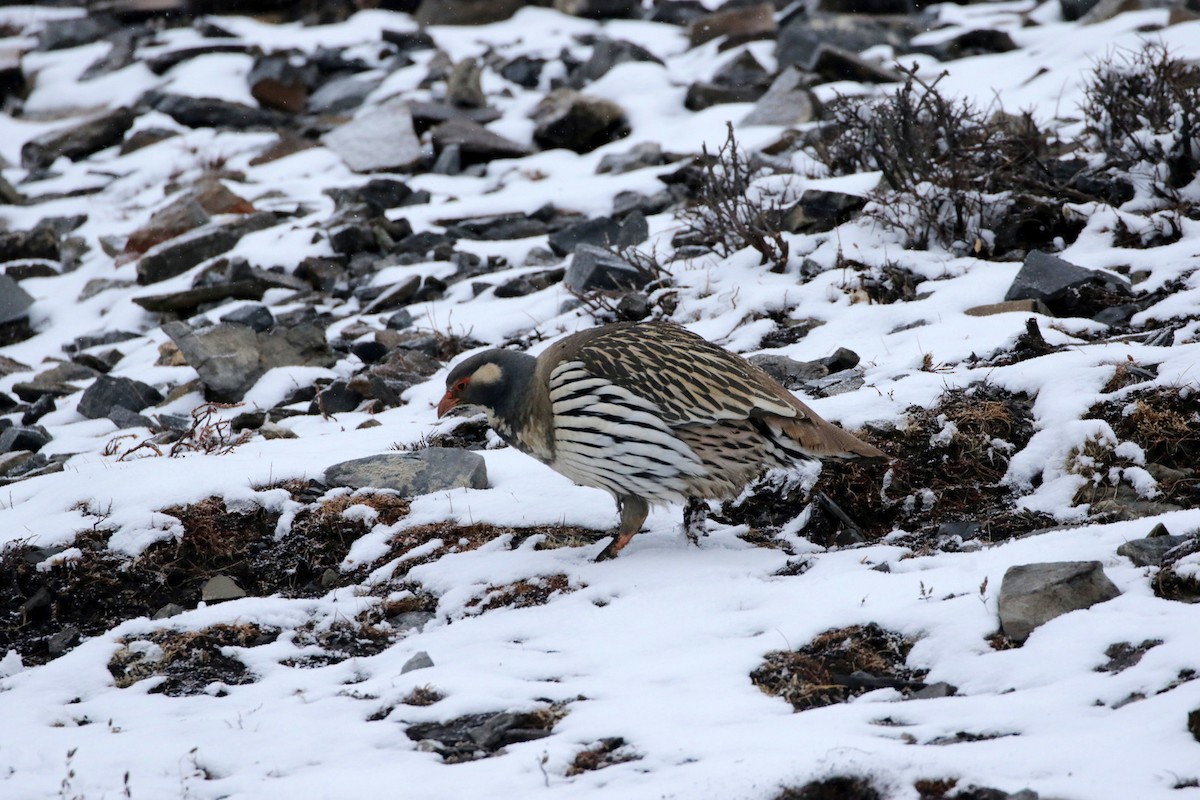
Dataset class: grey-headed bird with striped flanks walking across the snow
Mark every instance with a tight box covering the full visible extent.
[437,321,889,561]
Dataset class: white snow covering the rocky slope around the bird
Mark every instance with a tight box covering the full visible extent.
[0,0,1200,800]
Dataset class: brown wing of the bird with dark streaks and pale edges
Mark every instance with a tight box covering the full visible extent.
[569,323,809,427]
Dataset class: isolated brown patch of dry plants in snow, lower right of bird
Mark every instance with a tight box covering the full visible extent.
[750,622,925,711]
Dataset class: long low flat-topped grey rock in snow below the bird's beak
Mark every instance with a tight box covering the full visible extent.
[324,447,487,497]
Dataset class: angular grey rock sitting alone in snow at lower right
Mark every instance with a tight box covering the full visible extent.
[1000,561,1121,642]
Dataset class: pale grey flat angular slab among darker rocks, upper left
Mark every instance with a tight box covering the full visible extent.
[320,98,430,173]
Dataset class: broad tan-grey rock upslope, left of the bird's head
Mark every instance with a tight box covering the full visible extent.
[163,323,336,403]
